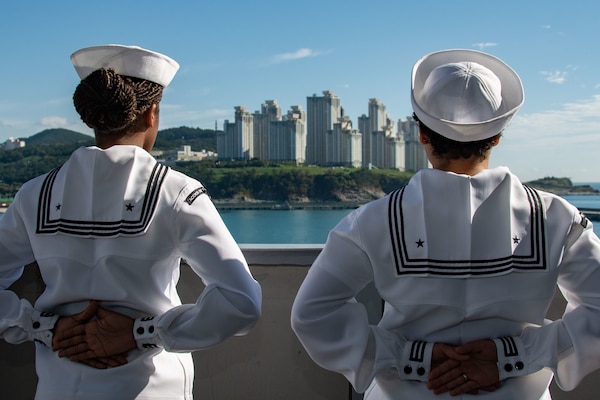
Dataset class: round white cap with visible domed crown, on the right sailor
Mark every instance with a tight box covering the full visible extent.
[411,49,524,142]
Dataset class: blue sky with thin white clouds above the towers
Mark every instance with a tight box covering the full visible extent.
[0,0,600,182]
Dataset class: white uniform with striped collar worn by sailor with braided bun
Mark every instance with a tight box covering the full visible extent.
[0,145,261,400]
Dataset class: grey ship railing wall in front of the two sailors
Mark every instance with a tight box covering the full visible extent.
[0,244,600,400]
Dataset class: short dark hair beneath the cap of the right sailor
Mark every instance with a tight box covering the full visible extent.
[413,113,502,160]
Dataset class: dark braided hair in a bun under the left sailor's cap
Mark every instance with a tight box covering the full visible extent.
[73,68,163,136]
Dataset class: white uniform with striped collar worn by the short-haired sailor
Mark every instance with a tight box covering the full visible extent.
[291,167,600,400]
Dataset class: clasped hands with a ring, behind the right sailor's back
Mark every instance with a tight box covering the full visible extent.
[427,339,500,396]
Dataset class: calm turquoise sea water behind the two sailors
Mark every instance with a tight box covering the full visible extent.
[221,187,600,244]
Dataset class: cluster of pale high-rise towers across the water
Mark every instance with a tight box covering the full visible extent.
[217,90,429,171]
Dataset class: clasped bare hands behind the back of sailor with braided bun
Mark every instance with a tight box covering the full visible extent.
[52,300,137,369]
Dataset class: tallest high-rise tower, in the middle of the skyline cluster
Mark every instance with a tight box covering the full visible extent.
[306,90,343,165]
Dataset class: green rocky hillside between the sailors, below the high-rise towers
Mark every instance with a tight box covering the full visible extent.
[173,161,412,204]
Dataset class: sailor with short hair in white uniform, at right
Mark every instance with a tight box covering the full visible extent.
[291,50,600,400]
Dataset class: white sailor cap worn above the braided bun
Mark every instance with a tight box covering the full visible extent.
[71,44,179,87]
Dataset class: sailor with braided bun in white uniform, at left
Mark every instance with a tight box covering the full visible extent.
[0,45,261,400]
